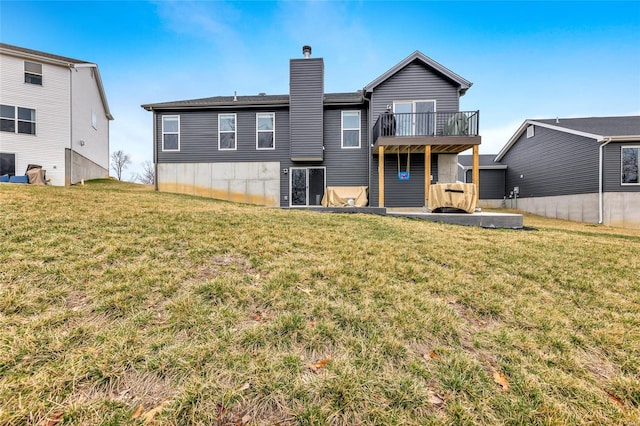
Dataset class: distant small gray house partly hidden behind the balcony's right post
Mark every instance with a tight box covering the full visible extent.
[458,154,507,208]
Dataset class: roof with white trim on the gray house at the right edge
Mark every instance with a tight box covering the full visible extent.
[495,115,640,161]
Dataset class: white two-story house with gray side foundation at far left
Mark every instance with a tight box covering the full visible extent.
[0,43,113,186]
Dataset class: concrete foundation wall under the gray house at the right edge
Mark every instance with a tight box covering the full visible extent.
[506,192,640,229]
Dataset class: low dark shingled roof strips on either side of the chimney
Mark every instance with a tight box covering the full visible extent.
[142,92,364,111]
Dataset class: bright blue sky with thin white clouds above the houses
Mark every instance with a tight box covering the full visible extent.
[0,0,640,178]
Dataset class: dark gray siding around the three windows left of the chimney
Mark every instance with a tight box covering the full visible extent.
[155,108,289,163]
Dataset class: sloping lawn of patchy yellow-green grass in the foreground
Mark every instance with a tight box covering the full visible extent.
[0,181,640,426]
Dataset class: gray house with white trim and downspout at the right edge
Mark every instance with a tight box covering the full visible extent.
[495,116,640,228]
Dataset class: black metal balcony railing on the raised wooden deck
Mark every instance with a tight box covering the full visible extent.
[373,111,480,141]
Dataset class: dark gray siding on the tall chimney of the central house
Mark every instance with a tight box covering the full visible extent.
[289,58,324,160]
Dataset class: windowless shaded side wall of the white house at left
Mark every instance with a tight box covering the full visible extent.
[71,67,109,171]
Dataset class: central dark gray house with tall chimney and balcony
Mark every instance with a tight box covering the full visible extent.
[142,46,480,207]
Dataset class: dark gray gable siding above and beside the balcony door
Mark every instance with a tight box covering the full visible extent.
[370,62,460,140]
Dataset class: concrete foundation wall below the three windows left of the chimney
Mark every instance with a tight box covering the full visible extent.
[157,162,280,207]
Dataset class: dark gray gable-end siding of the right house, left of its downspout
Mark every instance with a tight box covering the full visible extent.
[501,126,599,197]
